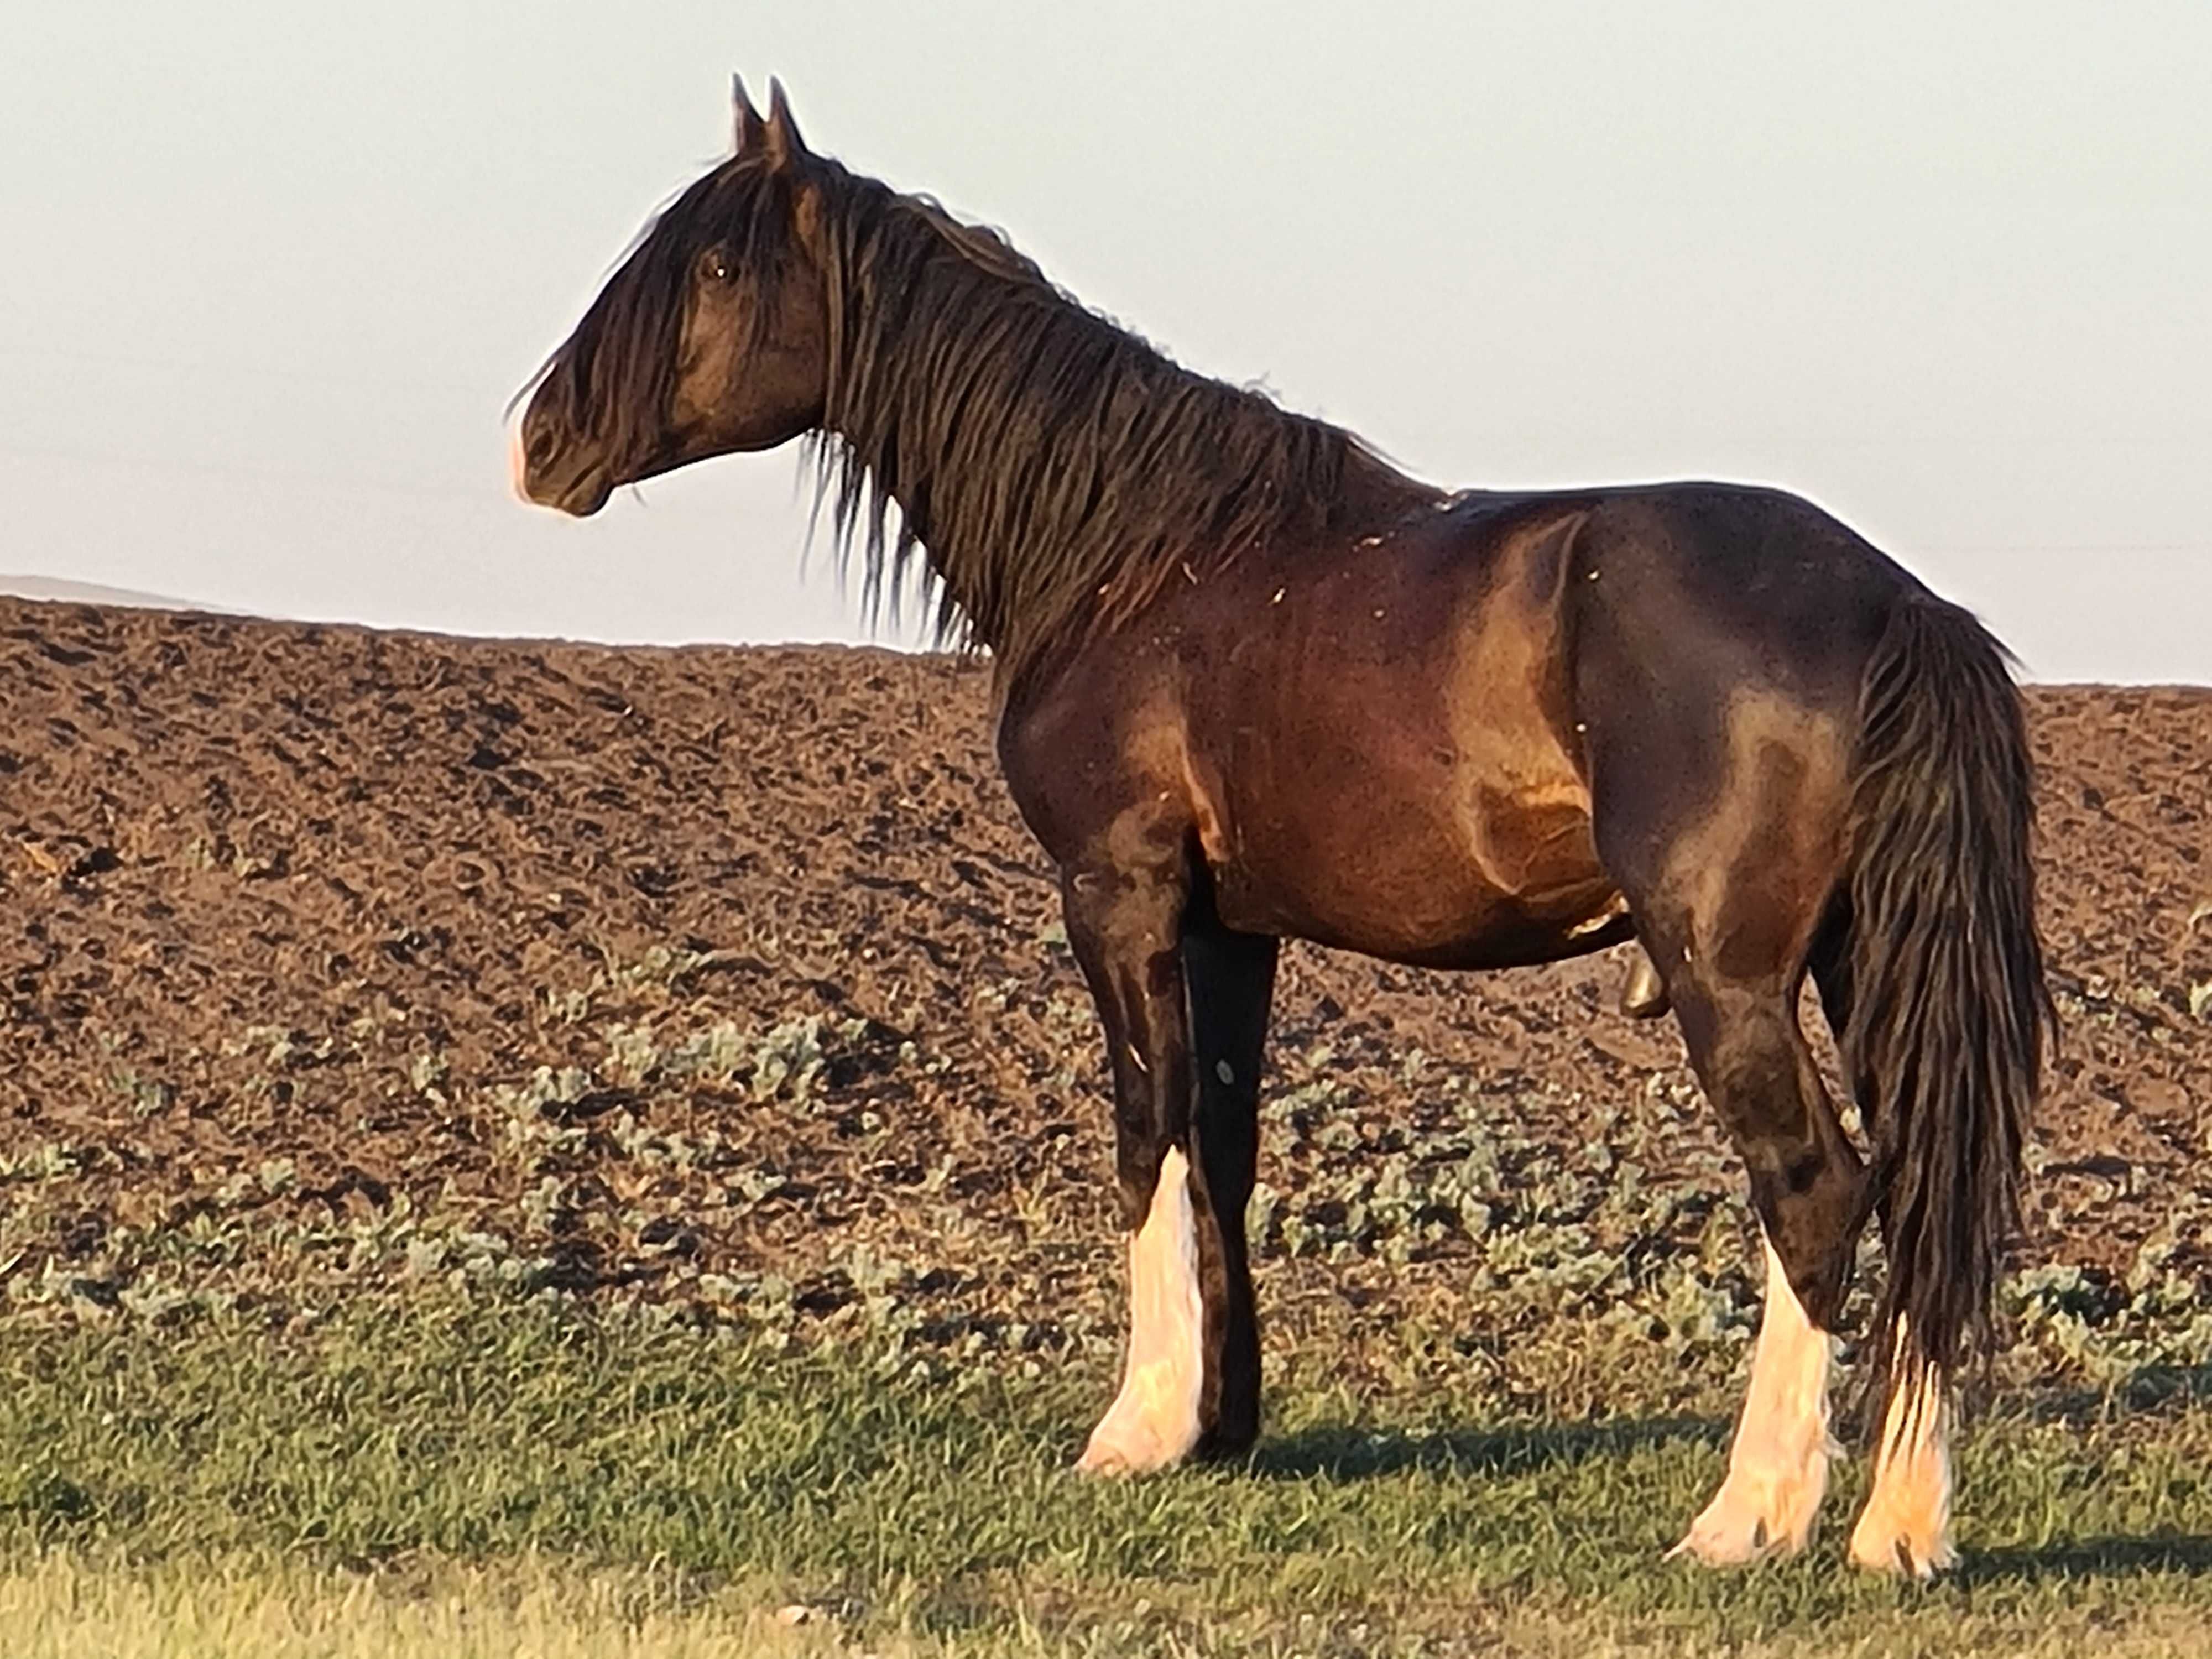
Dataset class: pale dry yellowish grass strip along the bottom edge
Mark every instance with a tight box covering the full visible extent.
[13,1553,2205,1659]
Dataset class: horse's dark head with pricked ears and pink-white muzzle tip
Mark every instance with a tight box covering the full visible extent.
[513,84,836,518]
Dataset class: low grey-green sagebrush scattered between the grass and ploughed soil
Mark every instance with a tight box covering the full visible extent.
[0,987,2212,1416]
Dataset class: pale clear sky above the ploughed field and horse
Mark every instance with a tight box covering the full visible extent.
[0,0,2212,681]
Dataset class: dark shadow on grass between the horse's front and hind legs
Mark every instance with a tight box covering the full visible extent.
[1245,1418,1728,1480]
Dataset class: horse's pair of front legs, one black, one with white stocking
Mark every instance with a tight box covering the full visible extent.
[1062,858,1274,1473]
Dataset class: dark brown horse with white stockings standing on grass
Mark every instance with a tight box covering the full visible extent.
[515,88,2051,1575]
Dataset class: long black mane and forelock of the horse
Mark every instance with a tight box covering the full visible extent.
[540,146,1391,675]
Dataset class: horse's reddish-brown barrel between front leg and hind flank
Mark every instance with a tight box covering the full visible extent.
[1183,515,1626,967]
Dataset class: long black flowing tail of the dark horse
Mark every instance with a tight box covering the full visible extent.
[1843,593,2055,1420]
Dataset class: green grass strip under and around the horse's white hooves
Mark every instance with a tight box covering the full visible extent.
[0,1301,2212,1655]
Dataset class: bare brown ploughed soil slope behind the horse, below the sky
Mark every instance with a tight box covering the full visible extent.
[0,599,2212,1407]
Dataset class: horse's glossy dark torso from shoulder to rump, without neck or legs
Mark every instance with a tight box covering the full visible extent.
[1006,484,1909,967]
